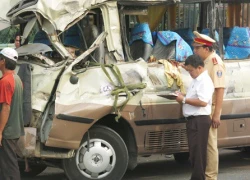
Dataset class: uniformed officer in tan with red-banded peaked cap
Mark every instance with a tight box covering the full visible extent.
[193,31,225,180]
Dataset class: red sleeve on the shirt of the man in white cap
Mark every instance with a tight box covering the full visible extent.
[0,73,15,105]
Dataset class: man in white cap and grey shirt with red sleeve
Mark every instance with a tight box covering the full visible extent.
[0,48,24,180]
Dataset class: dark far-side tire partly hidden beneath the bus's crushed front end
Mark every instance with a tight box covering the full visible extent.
[18,162,47,177]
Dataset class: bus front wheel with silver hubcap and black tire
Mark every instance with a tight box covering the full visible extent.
[63,126,129,180]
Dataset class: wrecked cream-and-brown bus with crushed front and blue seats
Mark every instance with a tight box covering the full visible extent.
[1,0,250,180]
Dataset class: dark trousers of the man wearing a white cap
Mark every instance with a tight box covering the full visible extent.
[0,139,21,180]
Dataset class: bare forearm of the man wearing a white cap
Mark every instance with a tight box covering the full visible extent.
[0,103,10,146]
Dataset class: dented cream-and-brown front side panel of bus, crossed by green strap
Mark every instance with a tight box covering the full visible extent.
[46,60,147,149]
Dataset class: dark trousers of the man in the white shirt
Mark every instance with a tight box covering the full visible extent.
[186,116,211,180]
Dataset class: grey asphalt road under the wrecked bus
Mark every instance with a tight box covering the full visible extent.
[22,149,250,180]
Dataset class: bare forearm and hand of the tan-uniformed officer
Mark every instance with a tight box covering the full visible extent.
[212,88,224,128]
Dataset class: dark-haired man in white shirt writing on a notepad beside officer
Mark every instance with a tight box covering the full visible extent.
[176,55,214,180]
